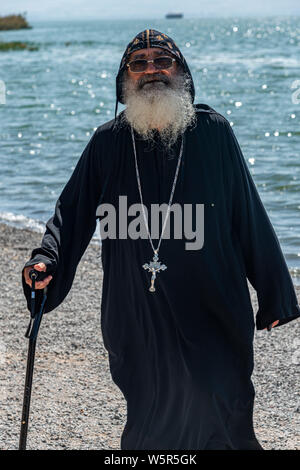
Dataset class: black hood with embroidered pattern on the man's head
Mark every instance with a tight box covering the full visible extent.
[115,29,195,119]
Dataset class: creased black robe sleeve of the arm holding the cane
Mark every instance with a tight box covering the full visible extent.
[22,131,101,313]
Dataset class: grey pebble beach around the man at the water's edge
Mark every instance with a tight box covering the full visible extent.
[0,224,300,450]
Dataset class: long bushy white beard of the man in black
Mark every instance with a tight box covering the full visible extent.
[121,72,197,149]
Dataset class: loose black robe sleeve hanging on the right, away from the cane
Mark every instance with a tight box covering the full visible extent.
[224,120,300,330]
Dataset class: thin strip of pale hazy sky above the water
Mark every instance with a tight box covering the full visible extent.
[0,0,300,21]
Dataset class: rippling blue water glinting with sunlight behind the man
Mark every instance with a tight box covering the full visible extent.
[0,17,300,284]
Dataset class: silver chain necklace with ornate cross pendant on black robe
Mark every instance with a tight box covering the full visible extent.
[131,126,184,292]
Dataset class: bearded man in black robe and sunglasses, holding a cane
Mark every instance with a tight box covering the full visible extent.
[22,29,300,450]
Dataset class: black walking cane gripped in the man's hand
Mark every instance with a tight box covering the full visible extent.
[19,269,47,450]
